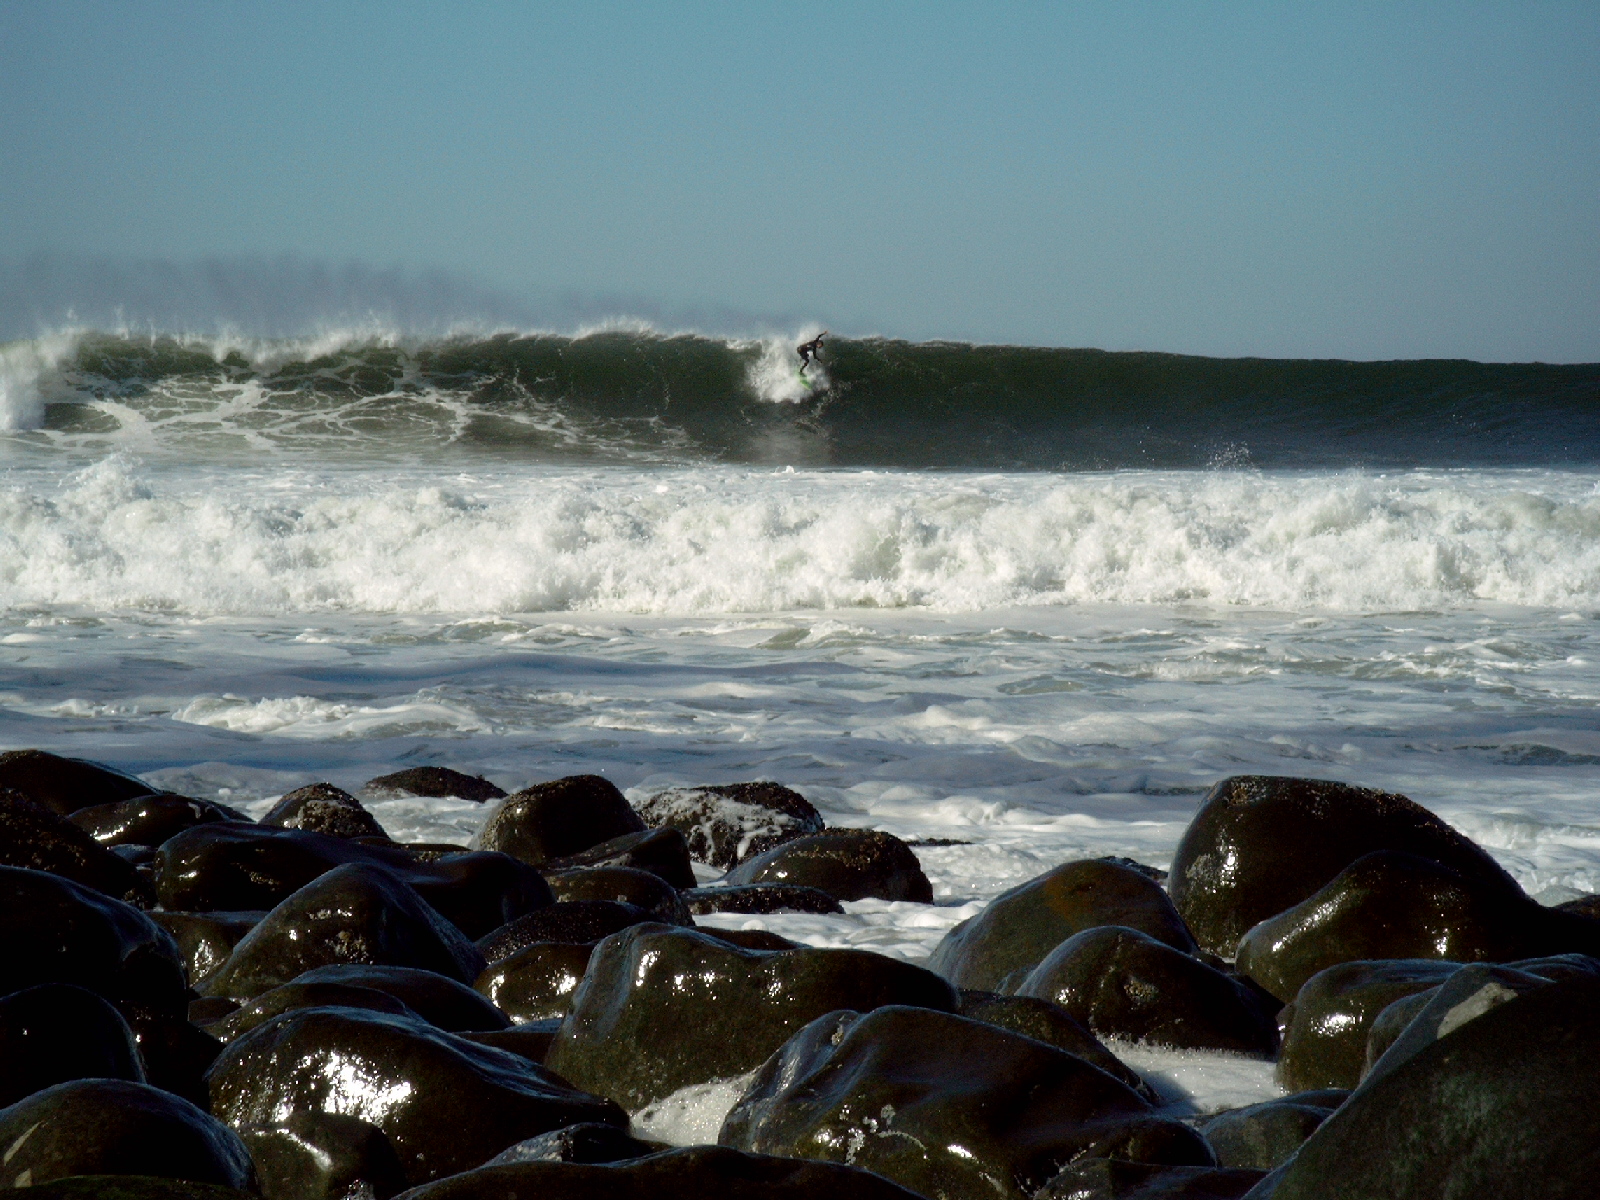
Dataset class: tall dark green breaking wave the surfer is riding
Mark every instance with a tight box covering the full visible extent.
[0,330,1600,470]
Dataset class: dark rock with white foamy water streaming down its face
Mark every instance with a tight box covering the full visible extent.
[638,782,824,870]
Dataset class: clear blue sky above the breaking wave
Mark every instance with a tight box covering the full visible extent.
[0,0,1600,360]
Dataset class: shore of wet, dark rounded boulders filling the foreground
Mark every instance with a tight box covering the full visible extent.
[0,750,1600,1200]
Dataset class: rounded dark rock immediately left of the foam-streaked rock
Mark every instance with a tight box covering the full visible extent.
[478,774,645,867]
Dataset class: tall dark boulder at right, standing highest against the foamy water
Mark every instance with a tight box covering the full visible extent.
[1170,774,1522,958]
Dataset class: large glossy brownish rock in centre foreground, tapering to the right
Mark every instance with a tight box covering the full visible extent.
[547,925,955,1110]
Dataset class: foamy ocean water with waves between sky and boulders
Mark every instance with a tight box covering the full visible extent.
[0,330,1600,1113]
